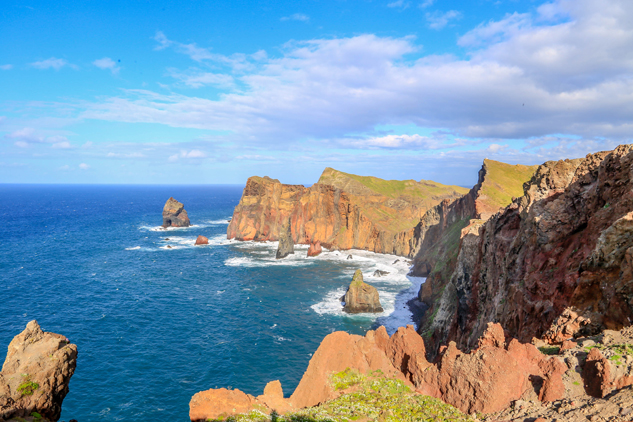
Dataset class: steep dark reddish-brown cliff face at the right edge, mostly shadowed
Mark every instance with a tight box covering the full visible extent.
[422,145,633,355]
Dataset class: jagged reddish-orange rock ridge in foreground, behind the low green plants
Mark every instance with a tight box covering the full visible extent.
[191,324,568,420]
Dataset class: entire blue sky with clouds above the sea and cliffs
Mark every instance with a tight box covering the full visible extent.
[0,0,633,186]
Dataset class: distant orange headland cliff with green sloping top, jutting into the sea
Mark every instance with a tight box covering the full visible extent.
[227,168,467,256]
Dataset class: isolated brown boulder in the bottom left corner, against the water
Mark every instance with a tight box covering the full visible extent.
[0,321,77,421]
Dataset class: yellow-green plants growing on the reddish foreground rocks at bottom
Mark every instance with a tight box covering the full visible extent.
[210,368,472,422]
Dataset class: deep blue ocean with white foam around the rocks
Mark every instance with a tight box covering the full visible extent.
[0,185,422,422]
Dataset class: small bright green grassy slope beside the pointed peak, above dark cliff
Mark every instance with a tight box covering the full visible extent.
[481,159,538,208]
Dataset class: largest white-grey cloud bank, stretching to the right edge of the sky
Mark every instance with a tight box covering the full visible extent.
[81,0,633,146]
